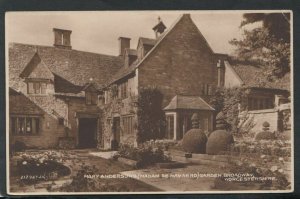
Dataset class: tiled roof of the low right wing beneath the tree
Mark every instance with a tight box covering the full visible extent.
[225,60,290,90]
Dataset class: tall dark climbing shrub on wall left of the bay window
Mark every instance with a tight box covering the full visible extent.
[137,88,165,143]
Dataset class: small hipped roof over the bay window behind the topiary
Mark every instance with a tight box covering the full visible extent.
[164,95,215,111]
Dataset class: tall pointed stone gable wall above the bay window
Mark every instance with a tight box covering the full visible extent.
[138,15,217,106]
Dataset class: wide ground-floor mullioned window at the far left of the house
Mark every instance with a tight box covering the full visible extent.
[11,117,40,135]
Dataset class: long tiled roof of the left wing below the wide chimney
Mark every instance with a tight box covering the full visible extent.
[9,43,124,91]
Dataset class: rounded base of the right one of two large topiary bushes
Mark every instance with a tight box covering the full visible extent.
[206,130,234,155]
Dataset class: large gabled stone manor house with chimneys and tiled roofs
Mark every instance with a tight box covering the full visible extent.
[8,14,290,149]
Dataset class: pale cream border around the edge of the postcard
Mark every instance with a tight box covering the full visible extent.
[5,10,294,196]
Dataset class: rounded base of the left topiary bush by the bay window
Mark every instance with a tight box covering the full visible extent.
[182,129,207,153]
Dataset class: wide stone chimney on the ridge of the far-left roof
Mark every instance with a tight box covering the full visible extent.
[53,28,72,49]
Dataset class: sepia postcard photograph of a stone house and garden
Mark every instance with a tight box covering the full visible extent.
[5,10,294,195]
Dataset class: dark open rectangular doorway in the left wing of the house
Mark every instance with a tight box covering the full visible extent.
[78,118,97,148]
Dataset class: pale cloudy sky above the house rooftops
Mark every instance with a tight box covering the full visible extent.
[5,11,258,55]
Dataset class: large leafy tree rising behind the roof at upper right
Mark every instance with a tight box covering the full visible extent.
[229,13,290,81]
